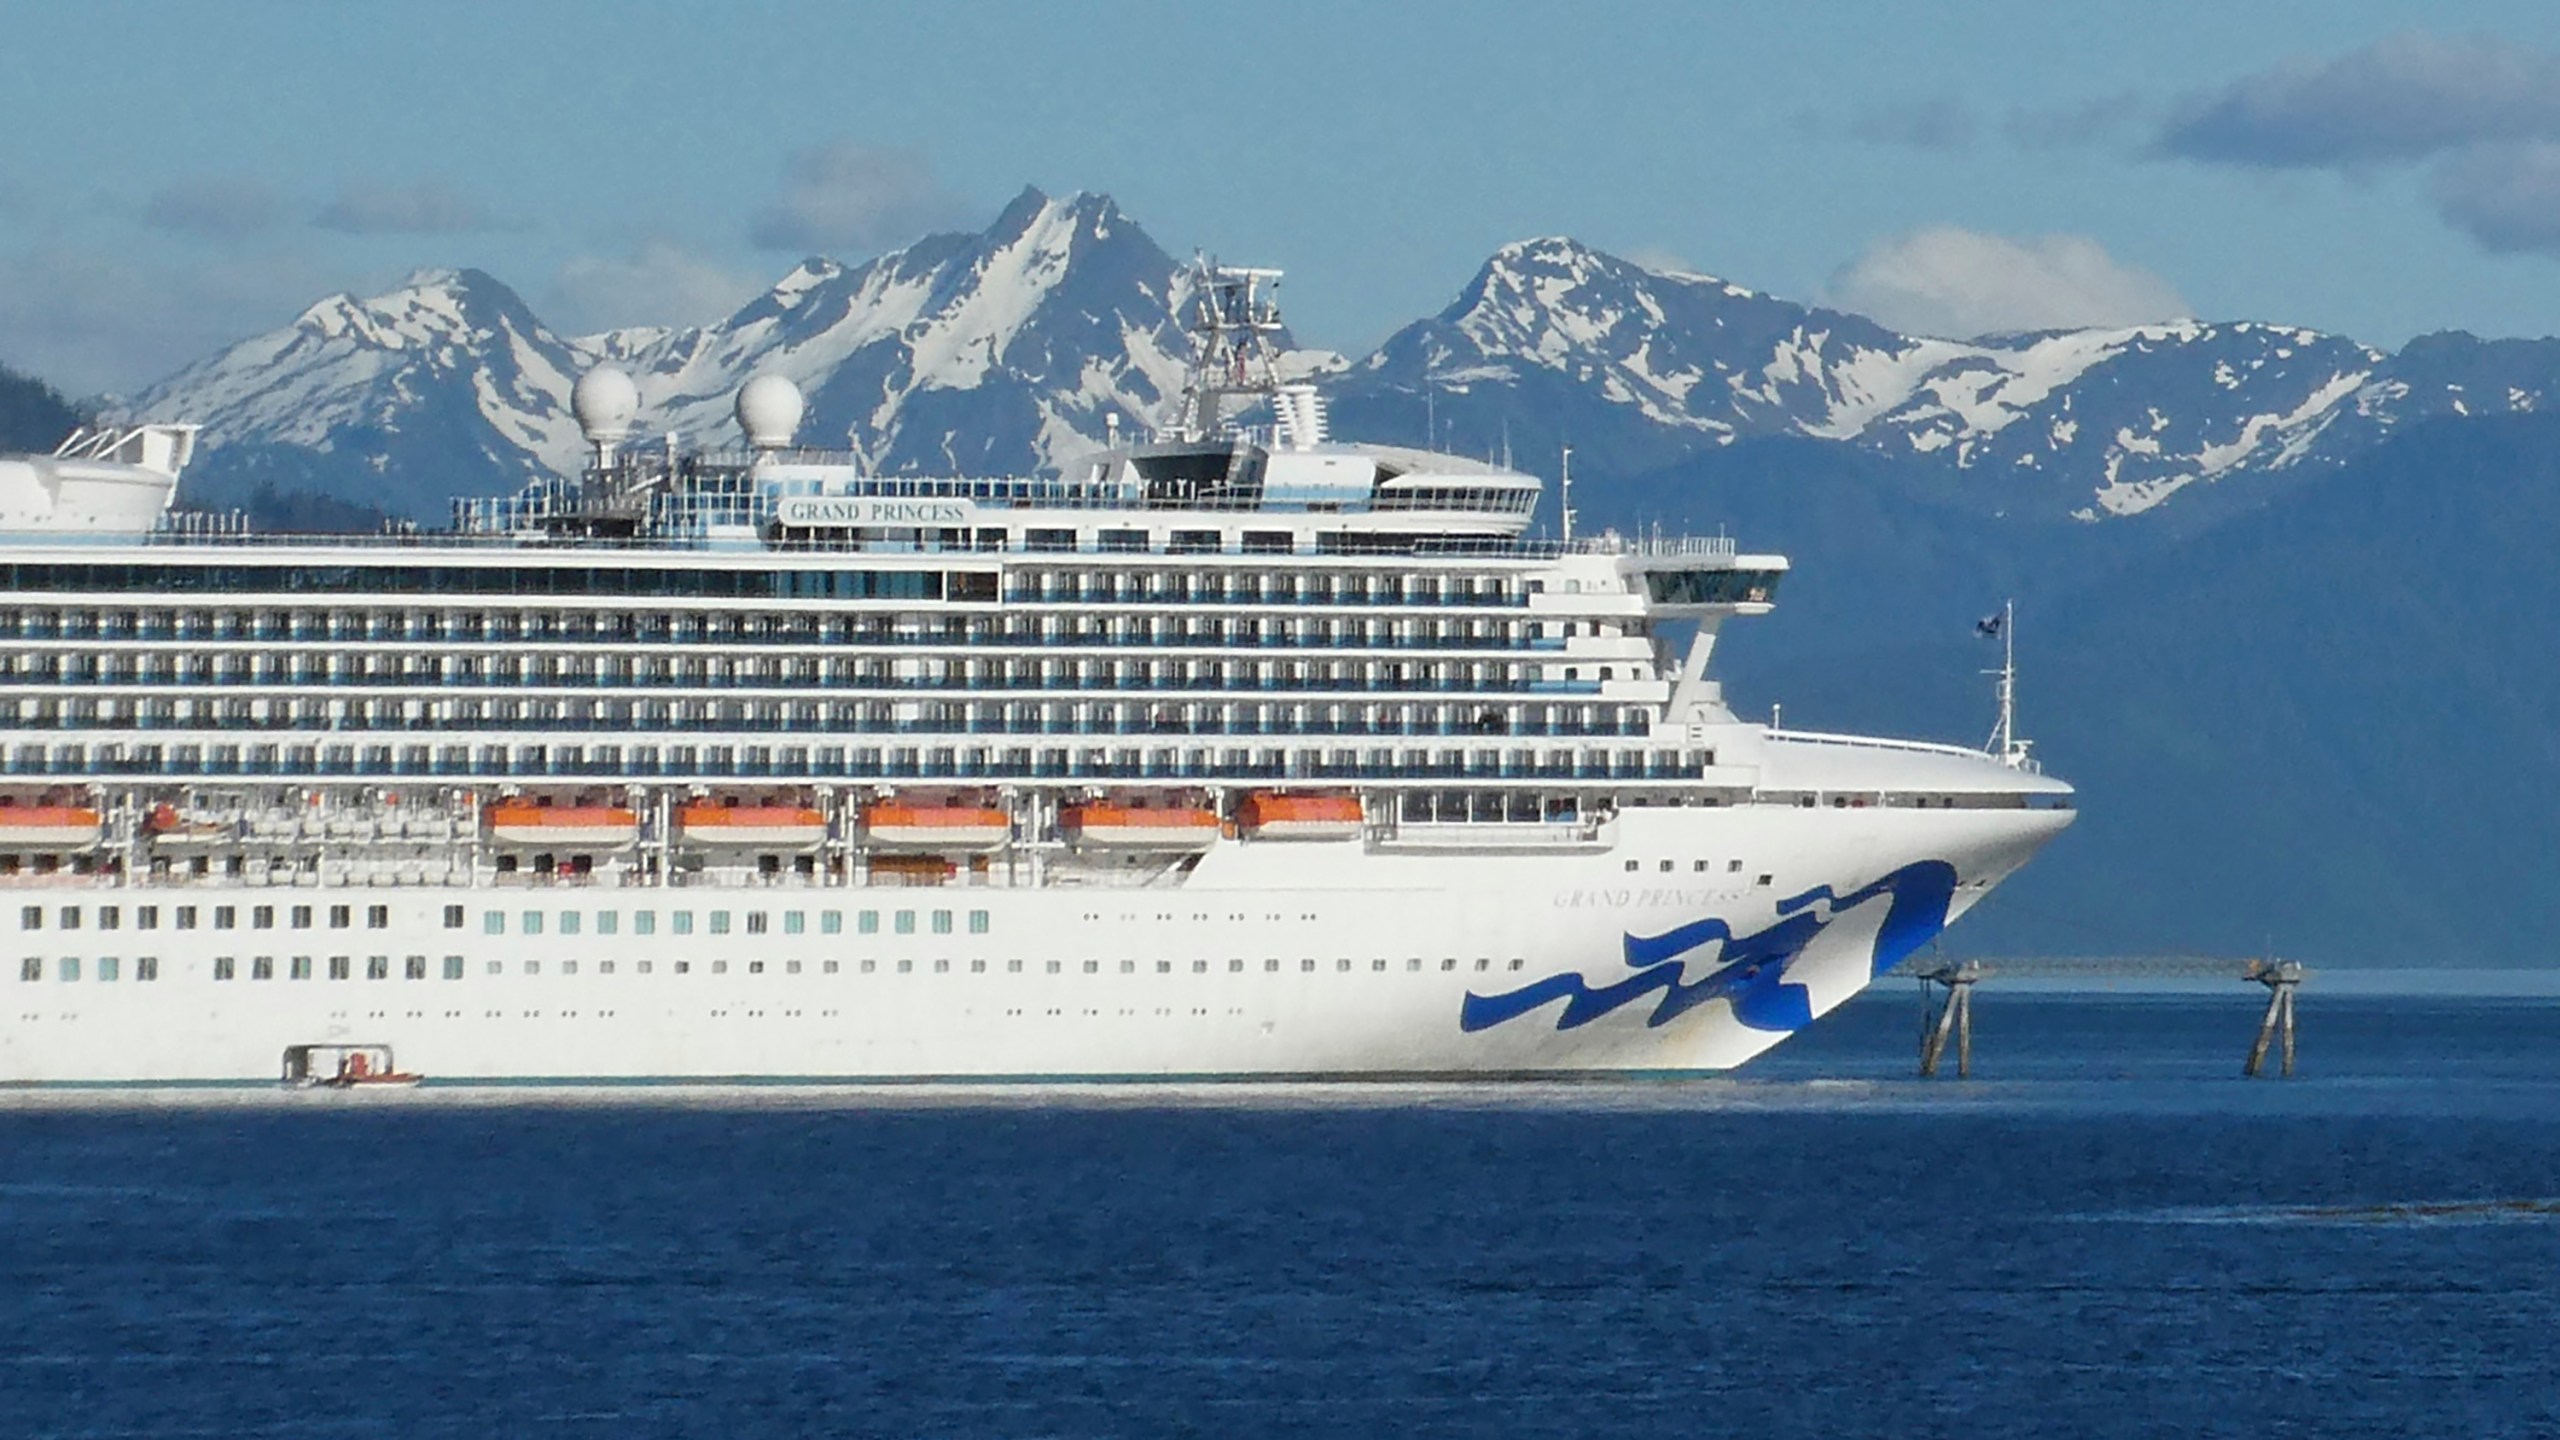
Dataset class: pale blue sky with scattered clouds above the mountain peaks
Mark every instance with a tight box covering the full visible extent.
[0,0,2560,392]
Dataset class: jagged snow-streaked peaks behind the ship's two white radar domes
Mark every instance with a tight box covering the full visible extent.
[128,190,1213,520]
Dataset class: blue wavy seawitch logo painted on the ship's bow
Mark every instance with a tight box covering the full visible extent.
[1457,861,1956,1035]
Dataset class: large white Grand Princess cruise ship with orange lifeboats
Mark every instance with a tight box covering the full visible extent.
[0,266,2074,1084]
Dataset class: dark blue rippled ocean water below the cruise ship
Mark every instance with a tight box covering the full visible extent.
[0,981,2560,1440]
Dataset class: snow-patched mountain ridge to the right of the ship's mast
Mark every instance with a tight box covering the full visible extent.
[1339,238,2560,520]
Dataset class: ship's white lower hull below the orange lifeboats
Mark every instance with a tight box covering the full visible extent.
[0,807,2071,1084]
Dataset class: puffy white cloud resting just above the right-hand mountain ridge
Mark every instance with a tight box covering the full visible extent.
[1825,225,2189,338]
